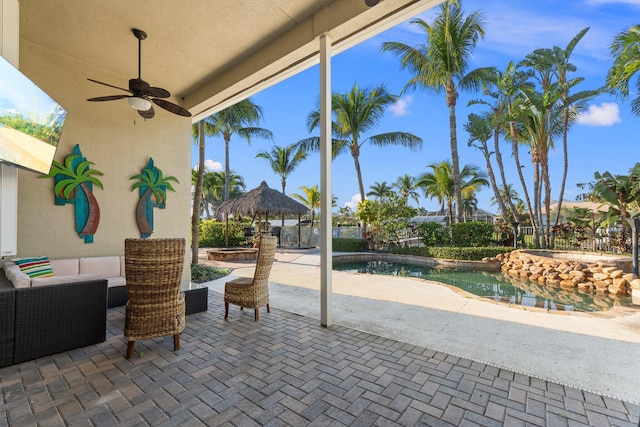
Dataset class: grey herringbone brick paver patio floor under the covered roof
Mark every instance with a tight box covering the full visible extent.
[0,291,640,427]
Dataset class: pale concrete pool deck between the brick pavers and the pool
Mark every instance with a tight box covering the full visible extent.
[203,249,640,403]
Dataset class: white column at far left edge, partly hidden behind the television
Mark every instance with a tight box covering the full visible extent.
[0,0,20,256]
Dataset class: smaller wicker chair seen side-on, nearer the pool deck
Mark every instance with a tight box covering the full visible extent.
[224,235,277,322]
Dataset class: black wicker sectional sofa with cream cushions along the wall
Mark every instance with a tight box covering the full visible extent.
[0,256,208,367]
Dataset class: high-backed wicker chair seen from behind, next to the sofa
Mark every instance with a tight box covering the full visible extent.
[124,239,185,359]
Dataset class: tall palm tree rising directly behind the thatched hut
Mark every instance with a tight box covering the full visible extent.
[206,98,273,201]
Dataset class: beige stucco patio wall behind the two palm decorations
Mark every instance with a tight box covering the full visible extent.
[13,41,192,286]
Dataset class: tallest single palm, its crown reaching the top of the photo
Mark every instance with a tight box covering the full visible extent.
[382,0,490,221]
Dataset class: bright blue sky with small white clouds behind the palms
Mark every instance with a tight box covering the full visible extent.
[192,0,640,212]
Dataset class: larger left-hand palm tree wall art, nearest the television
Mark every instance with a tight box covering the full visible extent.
[43,144,103,243]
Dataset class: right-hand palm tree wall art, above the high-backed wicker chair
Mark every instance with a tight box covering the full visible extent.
[131,158,178,239]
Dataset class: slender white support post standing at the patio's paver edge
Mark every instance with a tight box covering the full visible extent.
[320,34,333,327]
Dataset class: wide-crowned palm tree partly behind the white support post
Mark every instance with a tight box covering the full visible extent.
[298,83,422,206]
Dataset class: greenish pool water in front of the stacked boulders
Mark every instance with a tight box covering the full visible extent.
[333,261,633,312]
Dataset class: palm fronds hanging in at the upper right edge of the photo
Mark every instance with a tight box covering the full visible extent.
[607,24,640,116]
